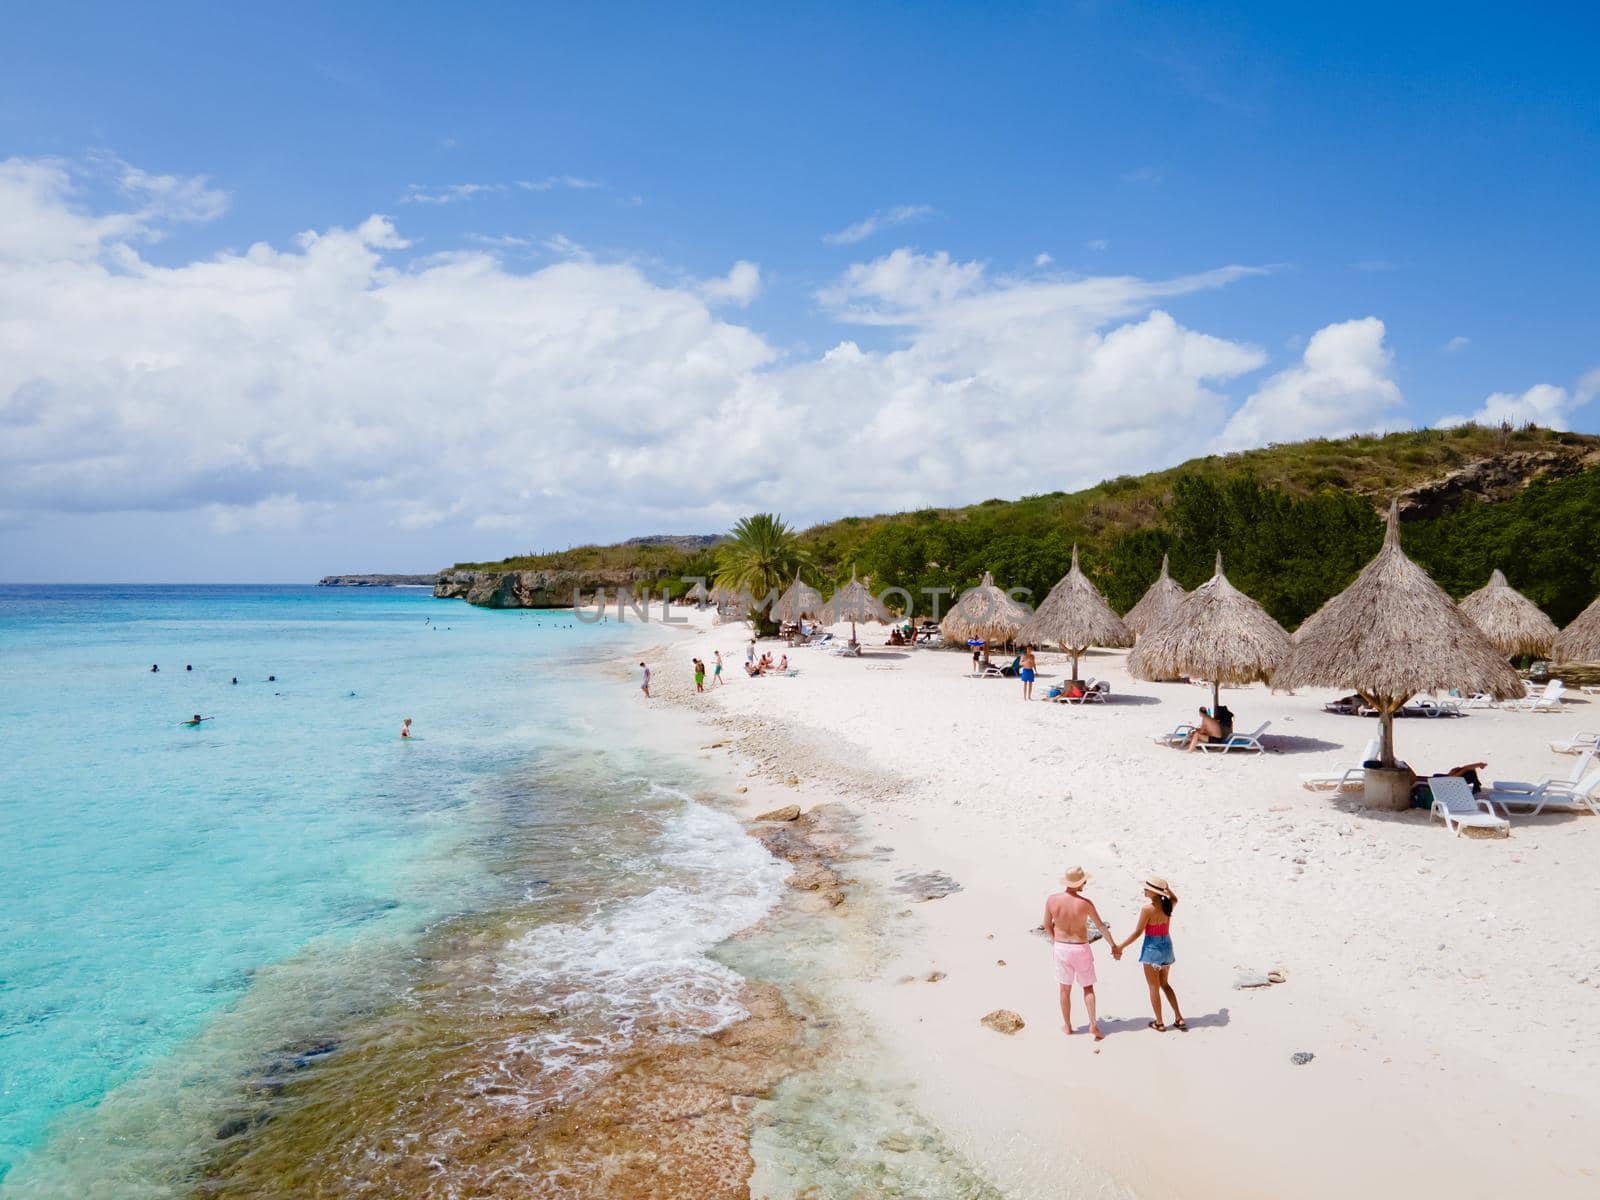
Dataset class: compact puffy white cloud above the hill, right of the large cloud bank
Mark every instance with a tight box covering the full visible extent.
[1216,317,1400,450]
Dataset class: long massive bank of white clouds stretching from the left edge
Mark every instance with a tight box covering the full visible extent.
[0,160,1299,560]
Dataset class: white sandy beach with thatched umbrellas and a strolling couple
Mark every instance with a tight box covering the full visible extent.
[651,613,1600,1197]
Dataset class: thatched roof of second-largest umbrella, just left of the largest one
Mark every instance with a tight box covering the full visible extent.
[1128,552,1290,685]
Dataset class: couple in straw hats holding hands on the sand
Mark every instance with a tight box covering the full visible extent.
[1045,867,1189,1042]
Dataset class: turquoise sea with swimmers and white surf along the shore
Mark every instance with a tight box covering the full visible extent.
[0,586,786,1200]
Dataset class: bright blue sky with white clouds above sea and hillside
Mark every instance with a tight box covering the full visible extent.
[0,3,1600,579]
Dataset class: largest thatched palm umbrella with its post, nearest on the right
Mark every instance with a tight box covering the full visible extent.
[1274,504,1523,766]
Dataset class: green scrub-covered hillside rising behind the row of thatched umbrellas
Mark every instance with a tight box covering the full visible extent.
[448,426,1600,629]
